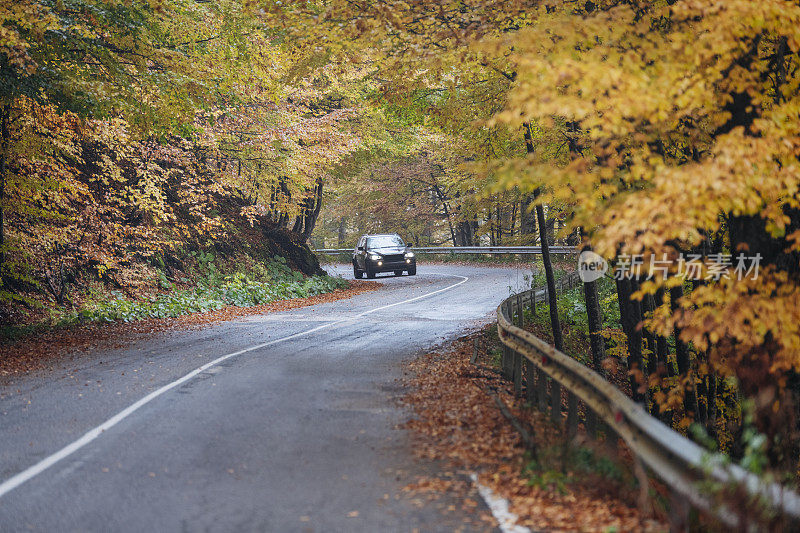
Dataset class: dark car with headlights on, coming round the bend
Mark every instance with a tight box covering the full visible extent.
[353,233,417,279]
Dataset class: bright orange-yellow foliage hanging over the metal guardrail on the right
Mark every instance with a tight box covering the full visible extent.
[481,0,800,466]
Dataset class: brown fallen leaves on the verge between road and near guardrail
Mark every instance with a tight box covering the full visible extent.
[402,330,668,532]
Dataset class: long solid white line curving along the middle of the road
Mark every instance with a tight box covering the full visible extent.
[0,274,469,498]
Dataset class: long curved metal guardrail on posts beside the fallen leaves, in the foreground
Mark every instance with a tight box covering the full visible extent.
[497,273,800,531]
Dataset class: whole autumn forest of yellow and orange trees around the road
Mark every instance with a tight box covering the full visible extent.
[0,0,800,490]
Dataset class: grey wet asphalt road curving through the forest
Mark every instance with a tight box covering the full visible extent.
[0,265,536,531]
